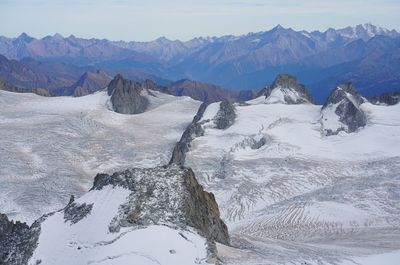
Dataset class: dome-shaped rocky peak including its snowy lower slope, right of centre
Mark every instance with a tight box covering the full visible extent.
[256,74,314,104]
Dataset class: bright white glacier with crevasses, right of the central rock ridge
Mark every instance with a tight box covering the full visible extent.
[185,97,400,265]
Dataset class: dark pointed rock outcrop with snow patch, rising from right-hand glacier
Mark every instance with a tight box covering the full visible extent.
[322,83,367,135]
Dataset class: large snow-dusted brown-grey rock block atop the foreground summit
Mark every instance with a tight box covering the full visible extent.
[92,165,230,244]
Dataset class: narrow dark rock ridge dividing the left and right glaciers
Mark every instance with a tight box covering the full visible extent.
[169,103,208,166]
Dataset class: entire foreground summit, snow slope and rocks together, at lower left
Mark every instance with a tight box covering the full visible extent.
[0,165,230,265]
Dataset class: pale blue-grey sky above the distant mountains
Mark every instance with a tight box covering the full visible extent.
[0,0,400,41]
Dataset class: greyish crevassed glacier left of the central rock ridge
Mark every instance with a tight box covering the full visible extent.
[0,91,200,223]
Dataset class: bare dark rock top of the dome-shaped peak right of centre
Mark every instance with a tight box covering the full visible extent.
[259,74,314,104]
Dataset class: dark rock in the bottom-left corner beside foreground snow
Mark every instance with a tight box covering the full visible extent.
[0,213,40,265]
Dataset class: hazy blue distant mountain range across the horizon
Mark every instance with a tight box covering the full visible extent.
[0,24,400,102]
